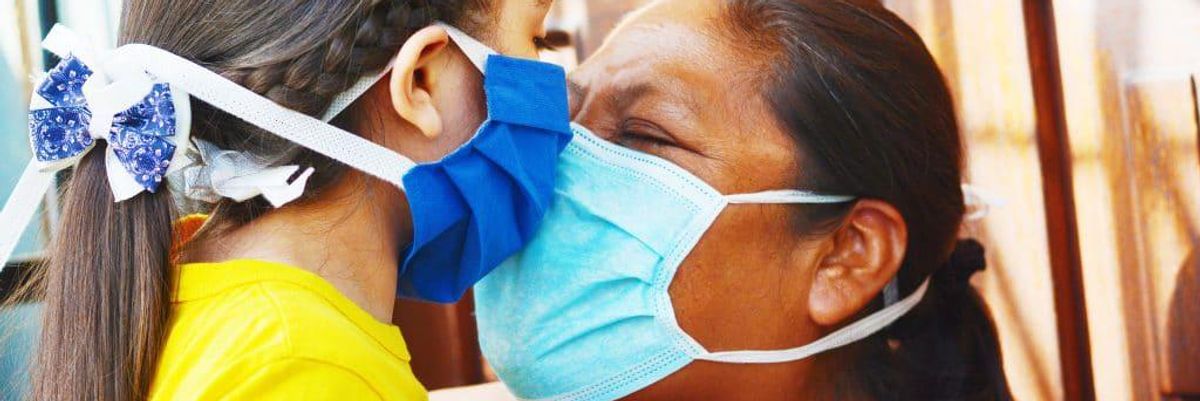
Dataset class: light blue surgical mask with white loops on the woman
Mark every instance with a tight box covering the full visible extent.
[475,125,928,401]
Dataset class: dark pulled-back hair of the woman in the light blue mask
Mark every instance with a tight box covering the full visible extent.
[719,0,1012,401]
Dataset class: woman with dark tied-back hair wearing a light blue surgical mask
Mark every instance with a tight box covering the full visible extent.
[475,0,1010,401]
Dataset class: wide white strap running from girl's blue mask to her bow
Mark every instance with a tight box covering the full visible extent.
[114,44,416,190]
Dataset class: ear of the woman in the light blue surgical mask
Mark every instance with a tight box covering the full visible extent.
[809,199,908,327]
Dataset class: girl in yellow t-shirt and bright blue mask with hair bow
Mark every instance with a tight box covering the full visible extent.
[0,0,570,400]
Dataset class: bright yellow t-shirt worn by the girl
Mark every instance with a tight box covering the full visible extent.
[150,256,428,401]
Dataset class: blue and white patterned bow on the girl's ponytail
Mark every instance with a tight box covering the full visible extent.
[29,25,190,202]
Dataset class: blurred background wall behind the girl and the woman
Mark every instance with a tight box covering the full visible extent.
[0,0,1200,401]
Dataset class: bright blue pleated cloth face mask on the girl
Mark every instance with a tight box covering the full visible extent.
[384,28,571,303]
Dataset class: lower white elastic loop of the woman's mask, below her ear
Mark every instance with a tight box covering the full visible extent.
[696,279,929,364]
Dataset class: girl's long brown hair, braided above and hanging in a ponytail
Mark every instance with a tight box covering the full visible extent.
[19,0,488,401]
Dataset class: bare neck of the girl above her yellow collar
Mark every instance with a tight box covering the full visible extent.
[185,173,412,322]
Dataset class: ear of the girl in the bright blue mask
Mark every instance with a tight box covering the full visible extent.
[388,26,450,138]
